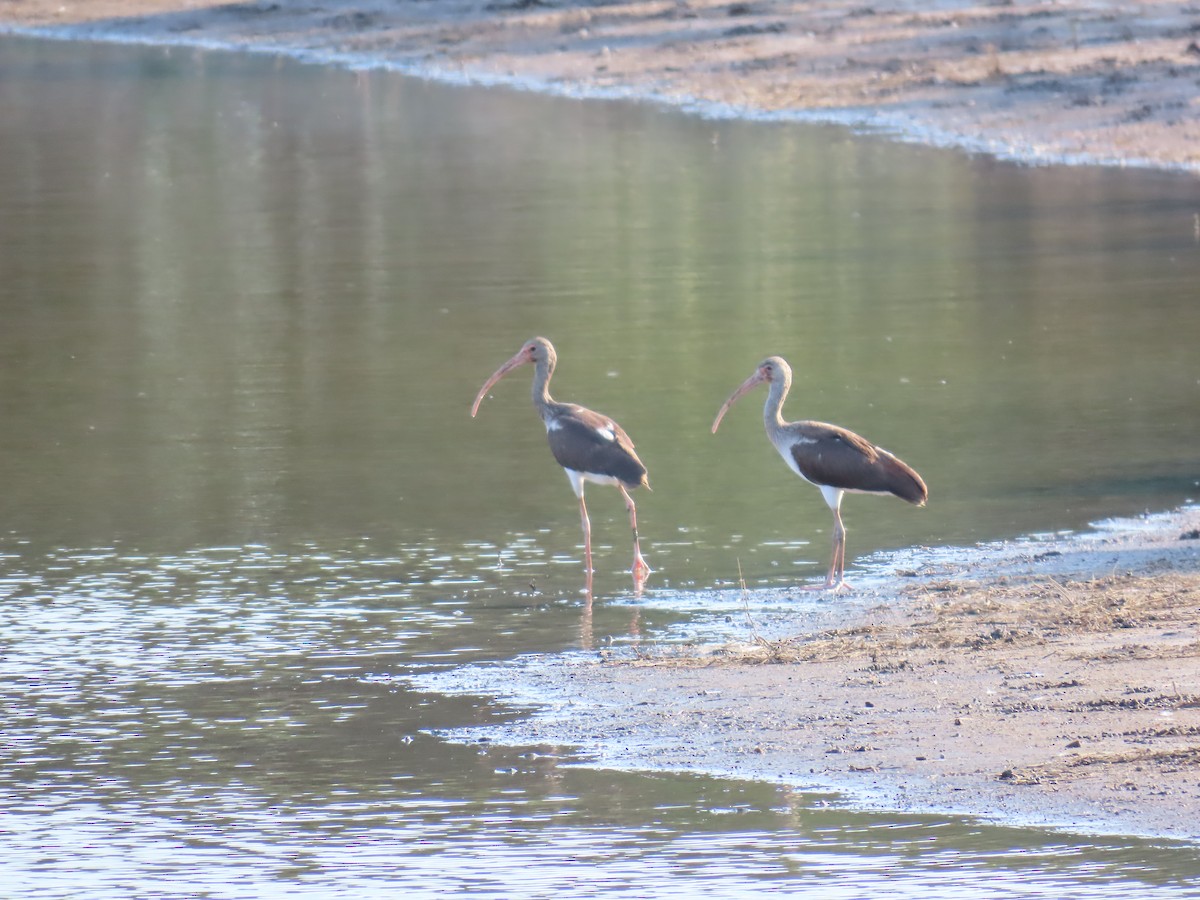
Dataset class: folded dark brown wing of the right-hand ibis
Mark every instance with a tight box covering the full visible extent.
[790,421,929,506]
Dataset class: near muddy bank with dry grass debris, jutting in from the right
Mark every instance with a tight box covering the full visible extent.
[422,508,1200,840]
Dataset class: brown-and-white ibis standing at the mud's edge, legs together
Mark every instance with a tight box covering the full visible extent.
[713,356,929,589]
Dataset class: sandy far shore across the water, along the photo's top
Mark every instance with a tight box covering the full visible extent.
[0,0,1200,172]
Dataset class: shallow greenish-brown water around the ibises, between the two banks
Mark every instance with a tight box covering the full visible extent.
[0,33,1200,898]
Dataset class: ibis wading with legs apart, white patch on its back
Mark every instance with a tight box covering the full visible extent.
[470,337,650,584]
